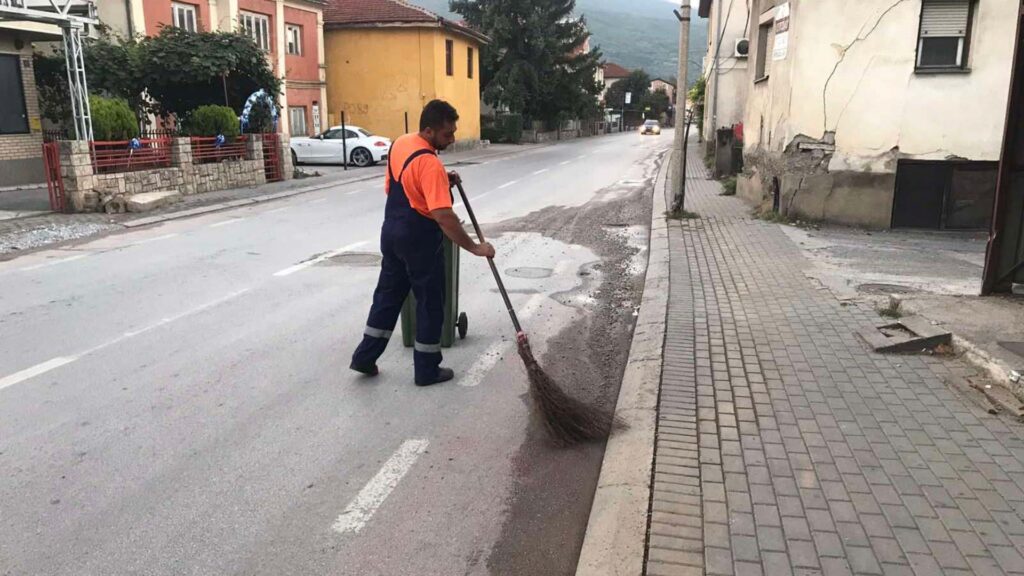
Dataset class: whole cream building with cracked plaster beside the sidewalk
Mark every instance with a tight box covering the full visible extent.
[737,0,1019,229]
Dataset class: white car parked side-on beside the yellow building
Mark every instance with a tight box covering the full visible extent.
[292,126,391,168]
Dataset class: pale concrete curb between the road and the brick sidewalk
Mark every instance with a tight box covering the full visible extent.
[577,146,672,576]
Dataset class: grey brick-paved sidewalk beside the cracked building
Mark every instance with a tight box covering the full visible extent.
[646,149,1024,576]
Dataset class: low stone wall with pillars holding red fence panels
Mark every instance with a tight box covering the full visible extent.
[59,136,293,212]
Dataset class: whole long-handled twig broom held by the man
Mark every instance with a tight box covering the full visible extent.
[456,182,615,446]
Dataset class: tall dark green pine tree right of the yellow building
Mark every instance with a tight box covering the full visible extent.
[451,0,602,125]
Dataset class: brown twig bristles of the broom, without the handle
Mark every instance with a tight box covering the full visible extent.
[518,335,623,446]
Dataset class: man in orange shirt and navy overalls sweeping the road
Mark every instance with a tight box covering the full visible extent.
[350,100,495,386]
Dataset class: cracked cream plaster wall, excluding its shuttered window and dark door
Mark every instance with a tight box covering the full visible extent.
[740,0,1017,228]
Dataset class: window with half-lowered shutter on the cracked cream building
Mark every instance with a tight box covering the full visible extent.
[918,0,973,71]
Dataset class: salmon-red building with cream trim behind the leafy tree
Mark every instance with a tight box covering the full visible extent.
[96,0,328,136]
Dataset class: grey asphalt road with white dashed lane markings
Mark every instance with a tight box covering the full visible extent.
[0,132,672,576]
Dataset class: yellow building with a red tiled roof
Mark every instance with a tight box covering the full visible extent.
[324,0,487,140]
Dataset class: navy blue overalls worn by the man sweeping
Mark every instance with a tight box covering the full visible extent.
[352,149,444,382]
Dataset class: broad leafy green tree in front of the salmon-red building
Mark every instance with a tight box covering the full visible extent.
[139,27,281,115]
